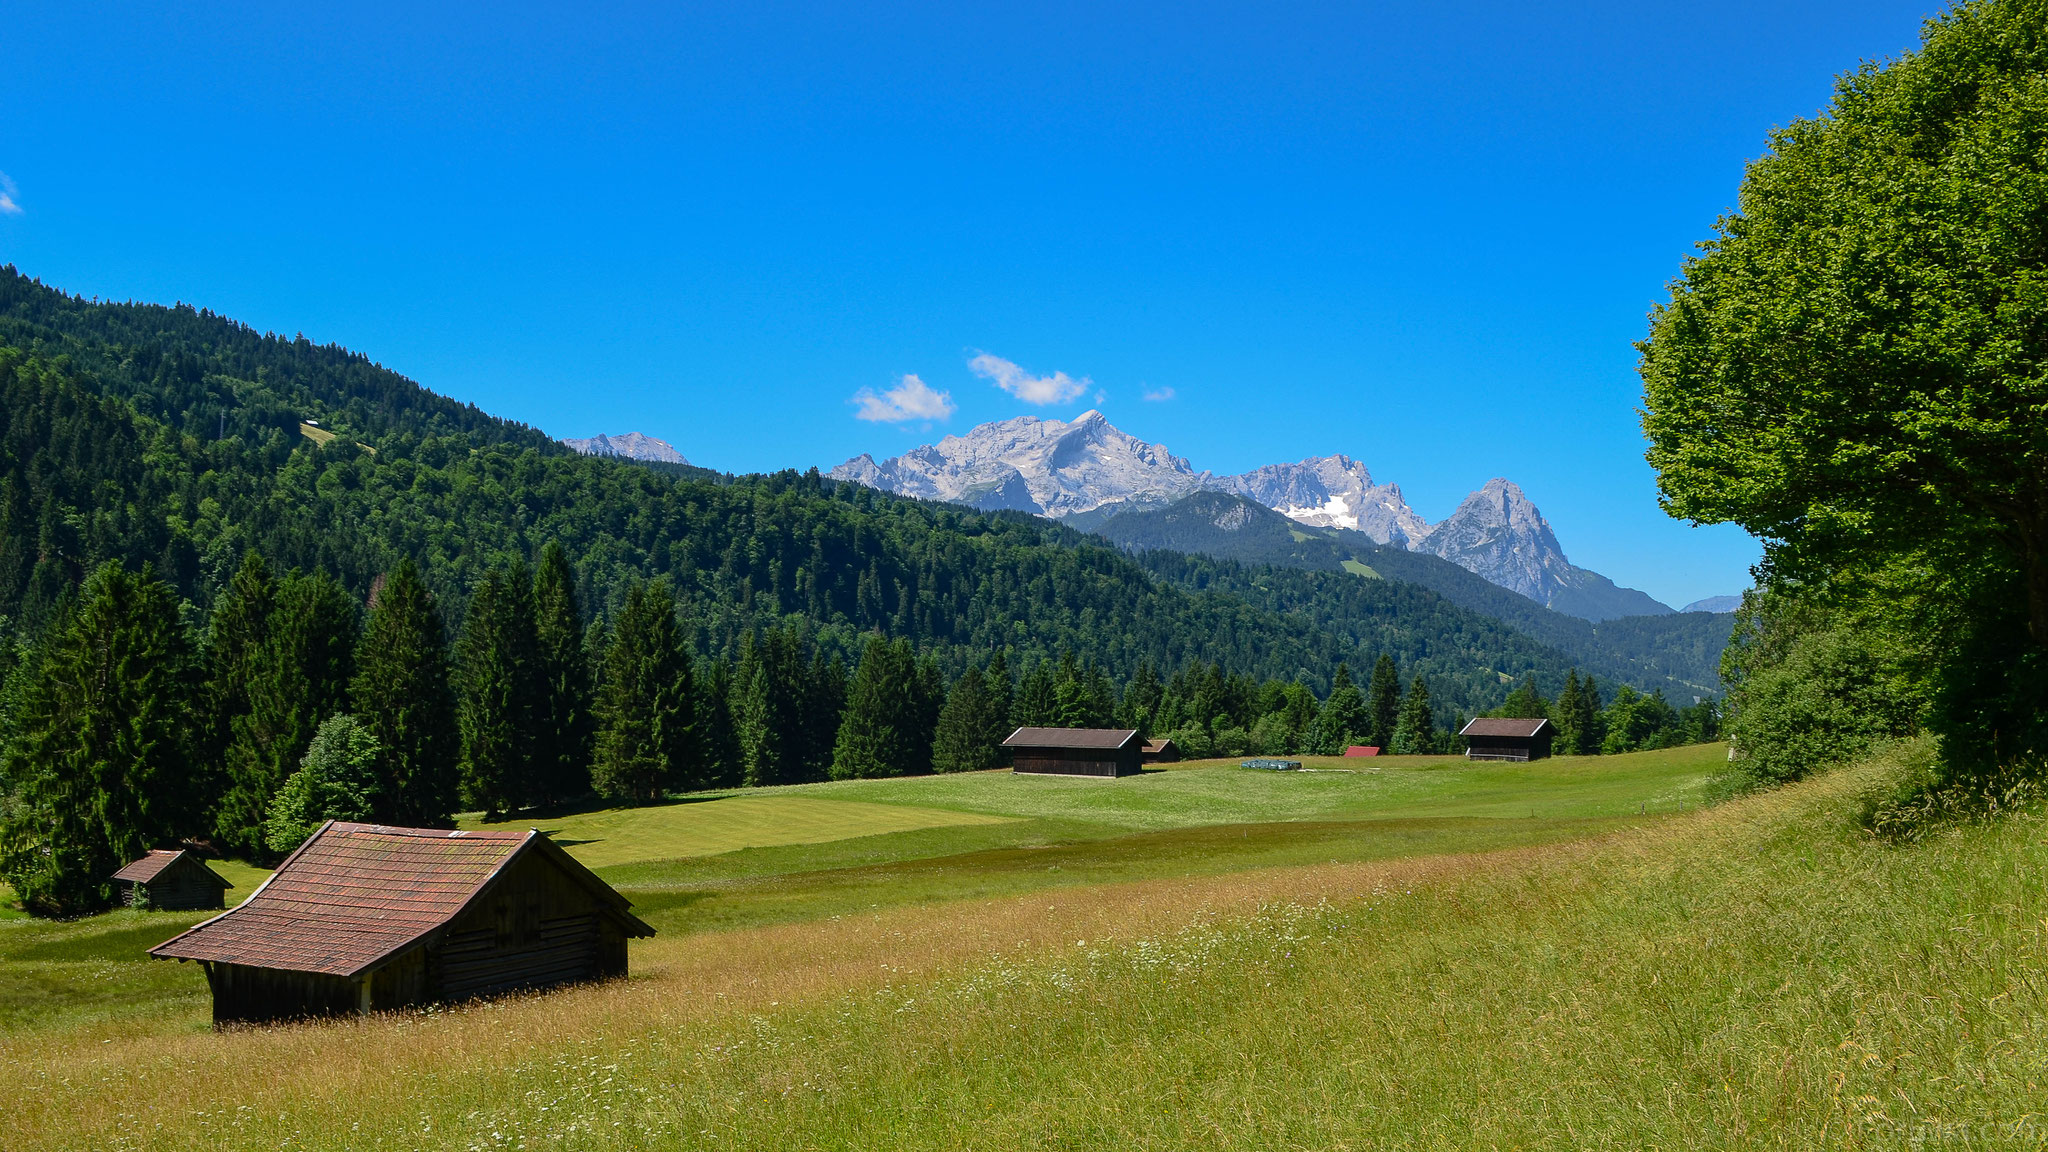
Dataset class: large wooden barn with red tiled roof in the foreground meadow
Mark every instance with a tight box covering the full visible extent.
[150,820,653,1025]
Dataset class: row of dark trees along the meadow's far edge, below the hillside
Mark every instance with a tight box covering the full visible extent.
[0,543,1714,914]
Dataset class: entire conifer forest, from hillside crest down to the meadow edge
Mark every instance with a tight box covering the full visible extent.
[0,269,1714,910]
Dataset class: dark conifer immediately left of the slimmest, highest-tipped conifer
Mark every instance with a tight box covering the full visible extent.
[455,564,547,822]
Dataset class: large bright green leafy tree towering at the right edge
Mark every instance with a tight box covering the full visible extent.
[1640,0,2048,763]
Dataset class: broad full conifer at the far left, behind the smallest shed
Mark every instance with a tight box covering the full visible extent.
[0,564,205,916]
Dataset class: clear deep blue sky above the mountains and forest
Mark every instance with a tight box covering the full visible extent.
[0,0,1933,605]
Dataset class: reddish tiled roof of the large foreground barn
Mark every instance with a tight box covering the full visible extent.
[150,822,653,976]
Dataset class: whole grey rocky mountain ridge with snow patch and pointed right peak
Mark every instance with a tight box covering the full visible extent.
[831,410,1671,621]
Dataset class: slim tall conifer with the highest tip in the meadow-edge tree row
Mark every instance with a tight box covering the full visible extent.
[532,541,596,804]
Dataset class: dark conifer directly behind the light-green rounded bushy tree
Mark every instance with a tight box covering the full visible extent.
[215,570,360,859]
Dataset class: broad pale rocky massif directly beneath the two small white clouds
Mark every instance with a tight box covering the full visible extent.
[831,412,1210,519]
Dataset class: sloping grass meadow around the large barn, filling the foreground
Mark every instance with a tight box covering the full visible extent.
[19,737,2048,1148]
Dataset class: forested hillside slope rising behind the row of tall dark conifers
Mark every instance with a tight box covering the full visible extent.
[0,269,1622,711]
